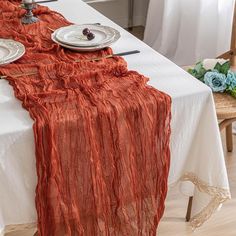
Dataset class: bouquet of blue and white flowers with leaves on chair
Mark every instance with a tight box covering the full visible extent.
[188,59,236,98]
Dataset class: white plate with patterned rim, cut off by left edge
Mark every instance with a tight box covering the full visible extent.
[0,39,25,65]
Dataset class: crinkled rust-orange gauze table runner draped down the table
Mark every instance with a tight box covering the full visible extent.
[0,0,171,236]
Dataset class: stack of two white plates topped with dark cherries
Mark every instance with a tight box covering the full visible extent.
[51,24,120,52]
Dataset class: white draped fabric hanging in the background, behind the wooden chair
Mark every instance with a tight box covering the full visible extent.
[144,0,235,65]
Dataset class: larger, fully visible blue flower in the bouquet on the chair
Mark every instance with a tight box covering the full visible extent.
[204,71,227,92]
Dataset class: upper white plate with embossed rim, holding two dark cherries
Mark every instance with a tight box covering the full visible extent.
[55,24,115,47]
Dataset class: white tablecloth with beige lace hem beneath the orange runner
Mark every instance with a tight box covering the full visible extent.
[0,0,229,234]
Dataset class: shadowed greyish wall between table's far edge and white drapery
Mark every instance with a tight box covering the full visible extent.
[84,0,149,27]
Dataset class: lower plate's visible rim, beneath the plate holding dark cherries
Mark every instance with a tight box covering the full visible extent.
[51,26,120,52]
